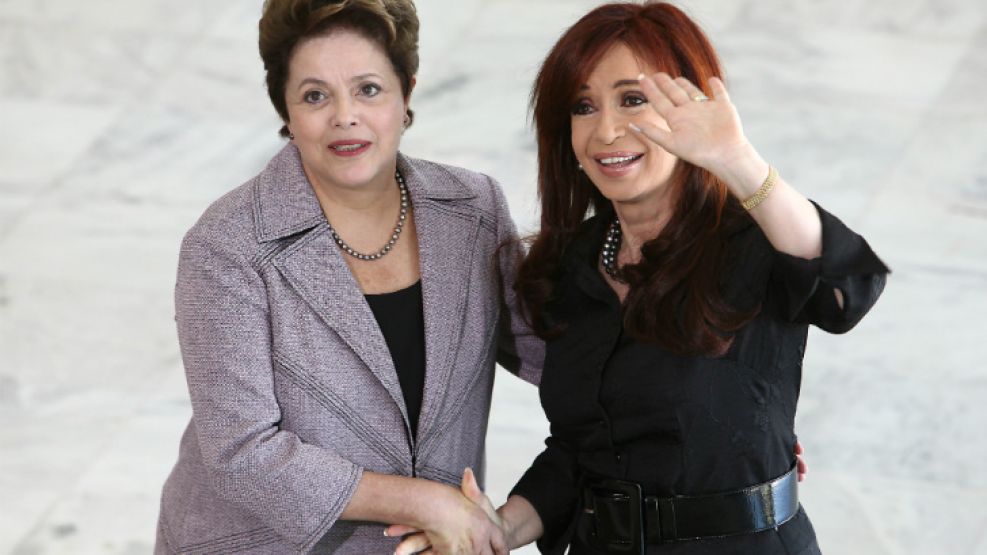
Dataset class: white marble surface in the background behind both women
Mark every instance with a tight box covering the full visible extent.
[0,0,987,555]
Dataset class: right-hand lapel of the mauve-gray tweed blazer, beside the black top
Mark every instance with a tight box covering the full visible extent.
[398,156,480,443]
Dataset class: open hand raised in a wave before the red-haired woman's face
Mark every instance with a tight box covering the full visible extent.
[631,72,750,174]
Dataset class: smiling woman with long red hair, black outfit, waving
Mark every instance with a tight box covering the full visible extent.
[398,2,888,554]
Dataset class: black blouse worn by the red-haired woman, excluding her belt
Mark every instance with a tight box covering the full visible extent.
[512,206,888,554]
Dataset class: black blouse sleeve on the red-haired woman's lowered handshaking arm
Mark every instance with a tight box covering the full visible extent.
[511,435,579,553]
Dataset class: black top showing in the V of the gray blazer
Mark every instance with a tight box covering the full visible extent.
[364,281,425,436]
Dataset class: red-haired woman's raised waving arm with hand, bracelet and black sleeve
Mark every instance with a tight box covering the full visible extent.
[631,73,888,326]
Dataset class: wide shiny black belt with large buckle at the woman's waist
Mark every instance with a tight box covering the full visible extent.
[583,467,799,553]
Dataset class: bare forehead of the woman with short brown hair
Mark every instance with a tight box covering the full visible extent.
[289,29,393,78]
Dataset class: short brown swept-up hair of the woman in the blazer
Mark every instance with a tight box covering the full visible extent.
[259,0,418,137]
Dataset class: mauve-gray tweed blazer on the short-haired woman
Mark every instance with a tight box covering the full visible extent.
[156,145,544,554]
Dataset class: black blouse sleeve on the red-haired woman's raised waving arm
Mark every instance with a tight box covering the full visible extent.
[770,203,890,333]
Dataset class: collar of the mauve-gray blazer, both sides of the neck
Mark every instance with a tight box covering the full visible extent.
[254,143,475,243]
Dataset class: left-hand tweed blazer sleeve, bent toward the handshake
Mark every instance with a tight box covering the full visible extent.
[175,229,362,552]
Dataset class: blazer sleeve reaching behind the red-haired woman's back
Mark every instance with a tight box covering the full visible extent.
[487,177,545,385]
